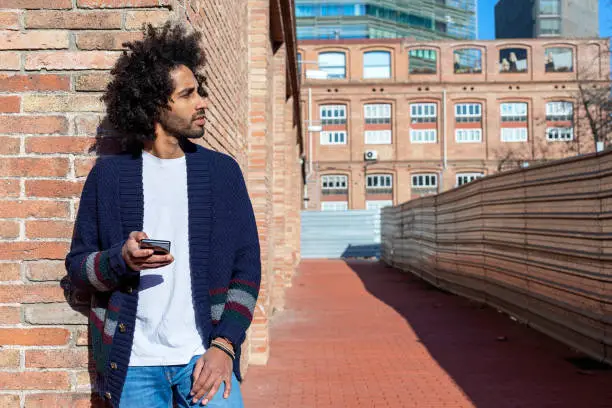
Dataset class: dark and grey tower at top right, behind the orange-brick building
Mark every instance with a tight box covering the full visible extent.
[495,0,599,39]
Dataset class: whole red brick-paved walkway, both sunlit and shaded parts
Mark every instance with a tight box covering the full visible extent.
[243,261,612,408]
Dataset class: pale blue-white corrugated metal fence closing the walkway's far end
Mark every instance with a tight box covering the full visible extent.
[301,210,380,259]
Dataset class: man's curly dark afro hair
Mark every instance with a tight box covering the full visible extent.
[102,21,207,153]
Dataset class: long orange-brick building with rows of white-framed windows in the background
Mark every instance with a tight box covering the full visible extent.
[298,38,610,210]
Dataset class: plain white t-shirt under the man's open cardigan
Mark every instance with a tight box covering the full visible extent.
[130,152,204,366]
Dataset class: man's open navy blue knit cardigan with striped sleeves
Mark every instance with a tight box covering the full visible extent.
[66,143,261,407]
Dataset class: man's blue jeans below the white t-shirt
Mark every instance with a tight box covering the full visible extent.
[119,356,244,408]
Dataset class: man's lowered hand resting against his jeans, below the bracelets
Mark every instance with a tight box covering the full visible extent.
[189,343,233,405]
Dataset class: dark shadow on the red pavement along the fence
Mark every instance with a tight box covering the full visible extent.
[346,260,612,408]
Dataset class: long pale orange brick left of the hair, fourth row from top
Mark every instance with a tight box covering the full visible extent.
[25,51,119,70]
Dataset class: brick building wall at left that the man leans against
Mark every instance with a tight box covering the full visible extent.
[0,0,303,408]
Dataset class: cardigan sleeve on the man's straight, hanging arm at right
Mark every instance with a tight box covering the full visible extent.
[212,159,261,345]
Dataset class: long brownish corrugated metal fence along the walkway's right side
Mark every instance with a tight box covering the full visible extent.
[382,153,612,363]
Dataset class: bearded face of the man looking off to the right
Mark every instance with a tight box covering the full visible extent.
[159,65,208,139]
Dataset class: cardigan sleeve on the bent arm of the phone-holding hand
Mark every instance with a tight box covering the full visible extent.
[65,164,131,292]
